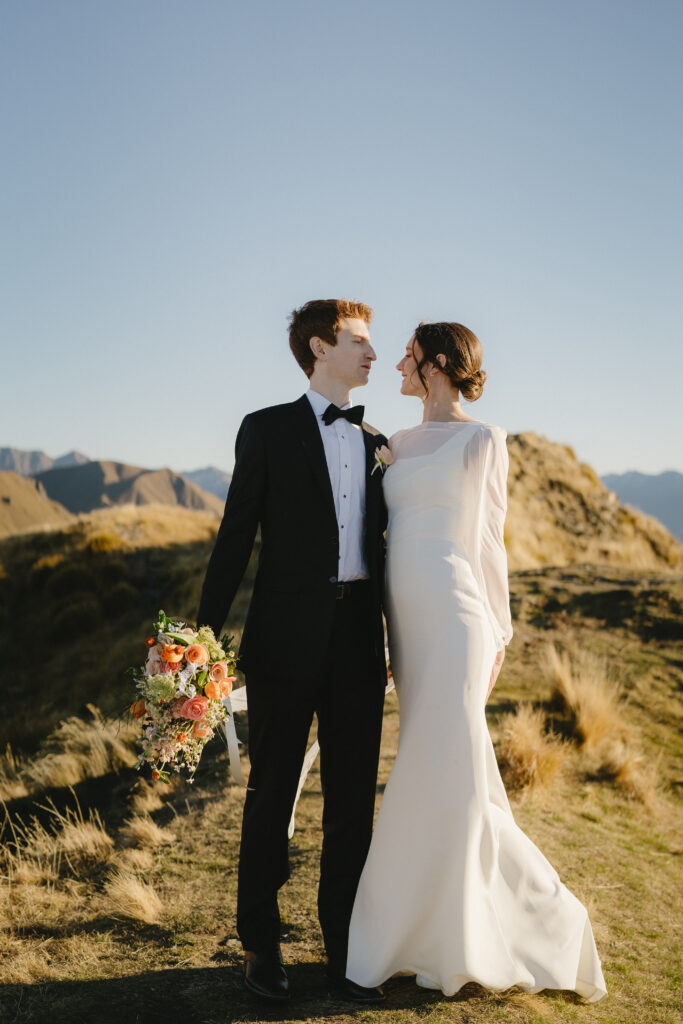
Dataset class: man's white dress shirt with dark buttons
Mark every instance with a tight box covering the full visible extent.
[306,388,369,583]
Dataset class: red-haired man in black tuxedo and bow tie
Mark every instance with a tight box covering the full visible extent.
[198,299,386,1002]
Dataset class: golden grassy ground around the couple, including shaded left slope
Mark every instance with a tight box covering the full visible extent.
[0,509,683,1024]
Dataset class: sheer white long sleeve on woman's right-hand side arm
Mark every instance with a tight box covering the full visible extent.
[473,427,512,650]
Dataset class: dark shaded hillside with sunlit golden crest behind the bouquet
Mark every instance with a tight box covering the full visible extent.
[0,506,250,751]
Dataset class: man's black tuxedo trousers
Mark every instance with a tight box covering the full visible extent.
[238,584,384,967]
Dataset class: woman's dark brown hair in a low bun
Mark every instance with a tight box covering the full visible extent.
[414,322,486,401]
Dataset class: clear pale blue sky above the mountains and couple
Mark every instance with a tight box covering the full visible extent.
[0,0,683,472]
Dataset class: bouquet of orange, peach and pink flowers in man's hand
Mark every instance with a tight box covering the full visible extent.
[128,611,237,782]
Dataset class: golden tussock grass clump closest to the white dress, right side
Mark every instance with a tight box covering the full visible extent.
[498,703,566,791]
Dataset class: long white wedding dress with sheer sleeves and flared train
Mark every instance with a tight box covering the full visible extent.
[347,422,606,1001]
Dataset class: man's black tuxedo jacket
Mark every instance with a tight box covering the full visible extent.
[197,395,387,685]
